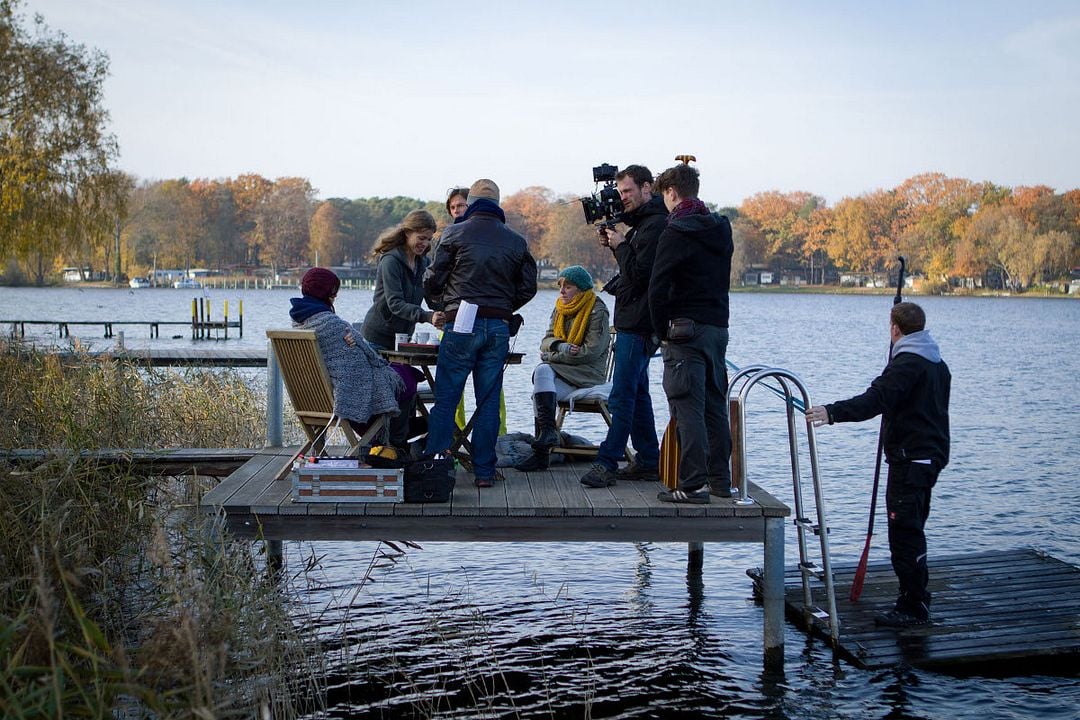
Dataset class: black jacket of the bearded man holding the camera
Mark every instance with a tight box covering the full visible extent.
[604,195,667,336]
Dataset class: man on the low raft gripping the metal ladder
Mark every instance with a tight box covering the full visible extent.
[807,302,953,627]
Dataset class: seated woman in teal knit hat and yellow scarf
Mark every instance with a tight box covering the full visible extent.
[515,266,611,472]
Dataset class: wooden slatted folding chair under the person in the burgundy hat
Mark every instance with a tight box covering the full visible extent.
[267,329,387,454]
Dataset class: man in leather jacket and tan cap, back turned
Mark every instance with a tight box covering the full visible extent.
[423,179,537,488]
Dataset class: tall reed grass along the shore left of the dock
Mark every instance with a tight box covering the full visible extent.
[0,343,323,718]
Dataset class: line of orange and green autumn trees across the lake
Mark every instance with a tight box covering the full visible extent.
[4,173,1080,290]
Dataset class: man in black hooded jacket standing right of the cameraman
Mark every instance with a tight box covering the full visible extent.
[649,164,734,503]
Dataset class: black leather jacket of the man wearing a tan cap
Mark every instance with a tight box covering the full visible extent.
[423,212,537,313]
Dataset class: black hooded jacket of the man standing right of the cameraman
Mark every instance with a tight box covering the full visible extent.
[649,213,734,340]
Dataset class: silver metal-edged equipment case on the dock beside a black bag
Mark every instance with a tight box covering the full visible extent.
[293,458,404,503]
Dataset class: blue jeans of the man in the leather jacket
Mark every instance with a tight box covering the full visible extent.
[424,317,510,478]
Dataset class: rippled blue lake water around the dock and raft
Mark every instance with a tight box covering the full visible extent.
[0,288,1080,719]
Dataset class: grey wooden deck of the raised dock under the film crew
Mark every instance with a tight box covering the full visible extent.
[201,448,789,542]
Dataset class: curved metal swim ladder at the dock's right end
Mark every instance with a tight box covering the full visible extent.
[727,365,839,648]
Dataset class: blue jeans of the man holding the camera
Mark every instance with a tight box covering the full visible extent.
[596,330,660,470]
